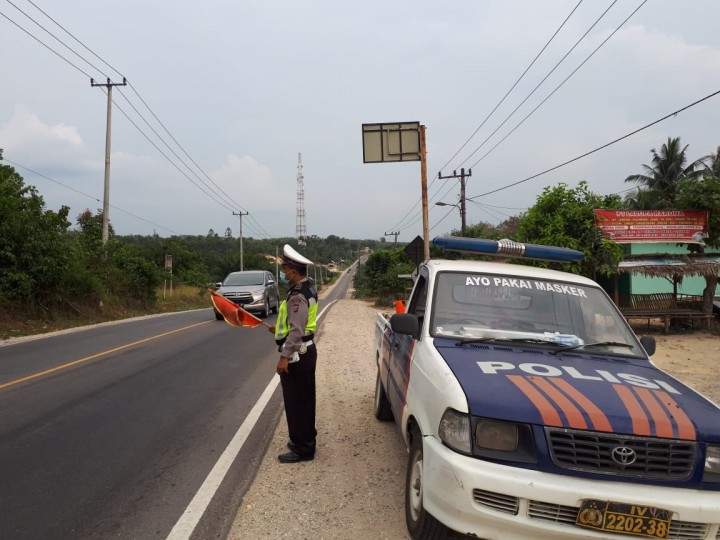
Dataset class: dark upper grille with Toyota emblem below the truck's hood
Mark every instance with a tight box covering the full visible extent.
[545,428,697,480]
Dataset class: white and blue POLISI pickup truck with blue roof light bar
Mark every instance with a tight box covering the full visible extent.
[374,237,720,540]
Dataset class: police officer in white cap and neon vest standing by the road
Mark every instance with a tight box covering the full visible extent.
[275,244,318,463]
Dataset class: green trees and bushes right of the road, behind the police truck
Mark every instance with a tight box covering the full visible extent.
[355,138,720,318]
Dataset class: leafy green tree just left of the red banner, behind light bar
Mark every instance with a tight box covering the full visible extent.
[518,182,623,279]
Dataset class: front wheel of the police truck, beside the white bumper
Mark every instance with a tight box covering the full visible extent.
[405,428,451,540]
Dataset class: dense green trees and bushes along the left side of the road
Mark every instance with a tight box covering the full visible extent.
[0,150,380,339]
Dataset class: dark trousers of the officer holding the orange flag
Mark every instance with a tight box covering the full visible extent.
[280,344,317,456]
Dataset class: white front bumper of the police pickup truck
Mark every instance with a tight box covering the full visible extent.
[423,437,720,540]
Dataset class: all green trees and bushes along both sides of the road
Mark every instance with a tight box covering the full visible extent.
[0,138,720,339]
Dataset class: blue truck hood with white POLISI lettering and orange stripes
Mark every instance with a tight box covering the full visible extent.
[434,338,720,442]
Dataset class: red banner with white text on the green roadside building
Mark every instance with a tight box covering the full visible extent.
[593,210,708,244]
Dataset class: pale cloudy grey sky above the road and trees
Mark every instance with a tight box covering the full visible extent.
[0,0,720,242]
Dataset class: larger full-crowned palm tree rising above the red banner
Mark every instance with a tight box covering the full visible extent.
[625,137,706,208]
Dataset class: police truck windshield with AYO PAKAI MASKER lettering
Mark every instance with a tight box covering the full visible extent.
[430,272,644,357]
